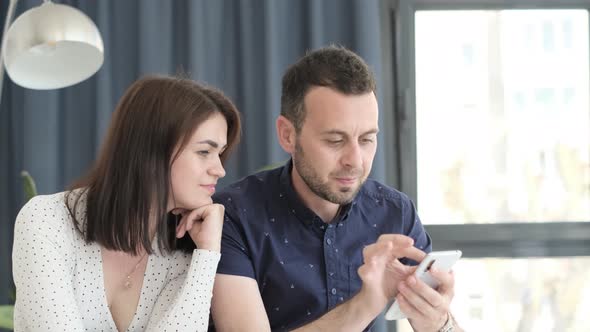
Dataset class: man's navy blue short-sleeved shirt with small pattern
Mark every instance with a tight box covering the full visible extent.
[214,162,431,331]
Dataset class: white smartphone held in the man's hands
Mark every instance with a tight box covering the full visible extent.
[385,250,462,320]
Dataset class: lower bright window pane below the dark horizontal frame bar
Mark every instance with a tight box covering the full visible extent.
[399,258,590,332]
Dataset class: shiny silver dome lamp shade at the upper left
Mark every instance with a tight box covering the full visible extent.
[2,1,104,90]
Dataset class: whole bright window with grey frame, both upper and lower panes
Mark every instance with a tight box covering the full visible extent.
[391,0,590,332]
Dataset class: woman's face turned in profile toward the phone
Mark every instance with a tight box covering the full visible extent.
[168,112,227,211]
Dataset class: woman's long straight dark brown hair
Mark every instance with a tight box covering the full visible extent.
[66,76,240,254]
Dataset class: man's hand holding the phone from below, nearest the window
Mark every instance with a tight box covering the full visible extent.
[396,268,455,332]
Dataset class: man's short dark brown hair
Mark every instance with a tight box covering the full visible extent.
[281,46,376,132]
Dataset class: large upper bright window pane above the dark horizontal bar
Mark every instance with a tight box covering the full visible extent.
[415,10,590,224]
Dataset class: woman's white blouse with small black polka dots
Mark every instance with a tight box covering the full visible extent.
[12,193,220,331]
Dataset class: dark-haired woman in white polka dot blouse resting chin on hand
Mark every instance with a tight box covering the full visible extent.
[13,77,240,331]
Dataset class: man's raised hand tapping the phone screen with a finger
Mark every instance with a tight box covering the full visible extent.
[358,234,426,314]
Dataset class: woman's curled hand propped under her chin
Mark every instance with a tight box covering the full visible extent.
[176,204,225,252]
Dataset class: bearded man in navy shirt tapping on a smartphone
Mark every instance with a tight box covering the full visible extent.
[212,47,458,331]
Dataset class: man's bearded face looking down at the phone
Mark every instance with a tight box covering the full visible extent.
[293,87,379,204]
